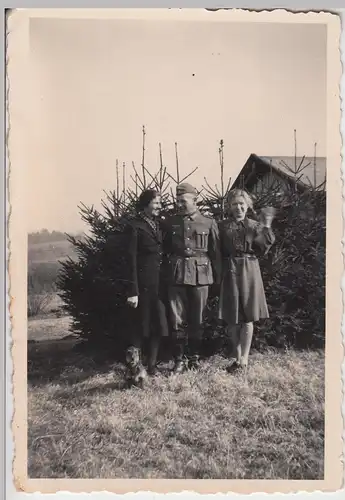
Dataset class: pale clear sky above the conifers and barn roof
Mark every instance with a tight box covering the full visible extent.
[27,18,326,232]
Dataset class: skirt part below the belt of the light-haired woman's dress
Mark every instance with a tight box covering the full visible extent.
[218,256,269,325]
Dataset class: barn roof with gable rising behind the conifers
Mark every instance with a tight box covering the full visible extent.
[233,154,326,190]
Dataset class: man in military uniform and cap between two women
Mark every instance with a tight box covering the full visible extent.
[163,183,221,373]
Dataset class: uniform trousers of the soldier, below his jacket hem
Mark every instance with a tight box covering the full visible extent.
[169,285,209,358]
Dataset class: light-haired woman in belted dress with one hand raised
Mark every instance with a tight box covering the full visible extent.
[219,189,275,372]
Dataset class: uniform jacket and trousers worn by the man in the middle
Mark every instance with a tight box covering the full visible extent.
[163,211,221,338]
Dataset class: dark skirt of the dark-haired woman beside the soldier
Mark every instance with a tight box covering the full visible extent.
[135,286,169,338]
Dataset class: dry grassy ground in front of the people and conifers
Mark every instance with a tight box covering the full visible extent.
[28,317,324,479]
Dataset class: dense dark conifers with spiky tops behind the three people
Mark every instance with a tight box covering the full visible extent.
[57,137,326,353]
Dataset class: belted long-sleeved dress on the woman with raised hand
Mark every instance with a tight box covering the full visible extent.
[219,218,275,325]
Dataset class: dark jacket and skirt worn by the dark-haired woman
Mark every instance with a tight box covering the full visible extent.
[126,216,168,337]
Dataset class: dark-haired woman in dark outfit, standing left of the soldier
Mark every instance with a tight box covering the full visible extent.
[127,189,168,375]
